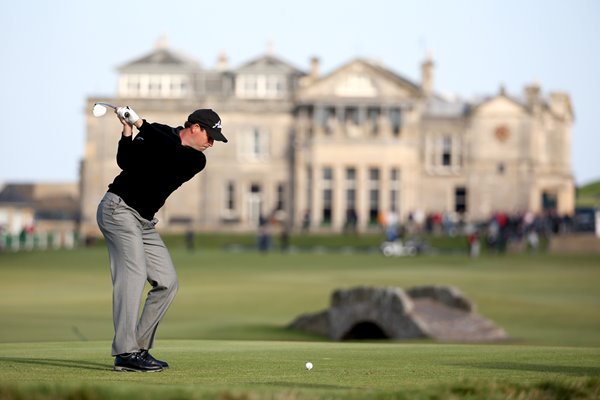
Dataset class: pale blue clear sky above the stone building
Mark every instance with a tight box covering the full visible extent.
[0,0,600,185]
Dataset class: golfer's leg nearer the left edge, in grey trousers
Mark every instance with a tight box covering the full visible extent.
[98,195,146,355]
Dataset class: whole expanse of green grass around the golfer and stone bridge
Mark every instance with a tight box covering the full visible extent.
[0,247,600,400]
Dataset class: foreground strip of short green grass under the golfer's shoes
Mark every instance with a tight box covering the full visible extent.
[0,340,600,399]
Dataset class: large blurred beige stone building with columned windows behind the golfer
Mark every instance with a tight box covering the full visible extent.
[81,39,574,236]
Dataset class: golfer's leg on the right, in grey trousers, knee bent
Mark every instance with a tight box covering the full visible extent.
[137,226,179,350]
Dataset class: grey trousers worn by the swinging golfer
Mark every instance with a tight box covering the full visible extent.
[96,193,178,355]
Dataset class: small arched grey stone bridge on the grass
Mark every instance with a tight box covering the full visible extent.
[290,286,507,342]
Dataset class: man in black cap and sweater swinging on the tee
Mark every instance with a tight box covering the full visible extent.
[96,107,227,372]
